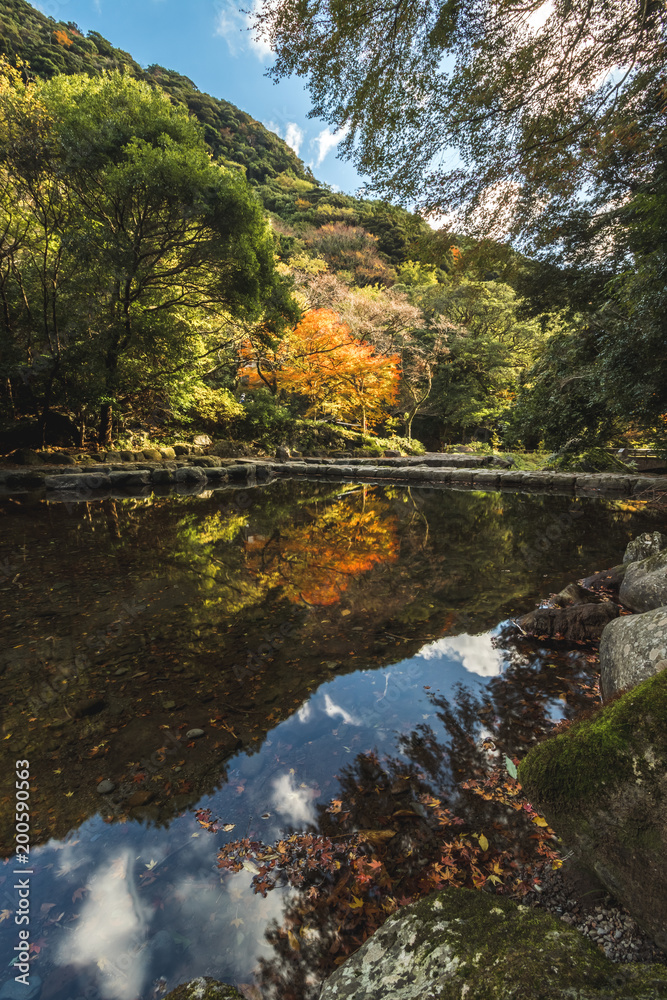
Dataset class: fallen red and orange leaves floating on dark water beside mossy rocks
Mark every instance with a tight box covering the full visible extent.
[215,751,560,1000]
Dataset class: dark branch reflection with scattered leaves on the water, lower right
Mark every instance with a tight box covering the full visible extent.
[237,634,604,1000]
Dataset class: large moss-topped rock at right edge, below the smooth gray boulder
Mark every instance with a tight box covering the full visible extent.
[519,671,667,950]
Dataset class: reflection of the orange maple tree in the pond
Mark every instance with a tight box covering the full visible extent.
[246,493,398,605]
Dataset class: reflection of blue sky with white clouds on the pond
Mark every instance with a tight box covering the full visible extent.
[0,634,502,1000]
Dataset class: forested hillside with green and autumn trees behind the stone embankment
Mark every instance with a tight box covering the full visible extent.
[0,0,667,463]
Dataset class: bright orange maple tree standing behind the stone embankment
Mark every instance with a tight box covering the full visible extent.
[240,309,400,431]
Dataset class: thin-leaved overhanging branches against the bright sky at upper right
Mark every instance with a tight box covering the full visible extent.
[255,0,665,250]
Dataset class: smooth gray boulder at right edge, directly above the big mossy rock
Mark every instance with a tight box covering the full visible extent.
[600,608,667,700]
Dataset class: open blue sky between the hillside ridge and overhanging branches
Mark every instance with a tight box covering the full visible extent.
[34,0,363,194]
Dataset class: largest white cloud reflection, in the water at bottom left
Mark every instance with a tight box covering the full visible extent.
[57,851,149,1000]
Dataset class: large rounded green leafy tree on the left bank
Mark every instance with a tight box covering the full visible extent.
[0,74,295,444]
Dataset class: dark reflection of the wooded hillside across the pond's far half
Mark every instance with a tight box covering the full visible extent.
[0,483,648,842]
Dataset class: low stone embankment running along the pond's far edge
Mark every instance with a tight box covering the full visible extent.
[0,449,667,501]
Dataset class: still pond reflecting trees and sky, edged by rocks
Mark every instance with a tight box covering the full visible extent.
[0,483,654,1000]
